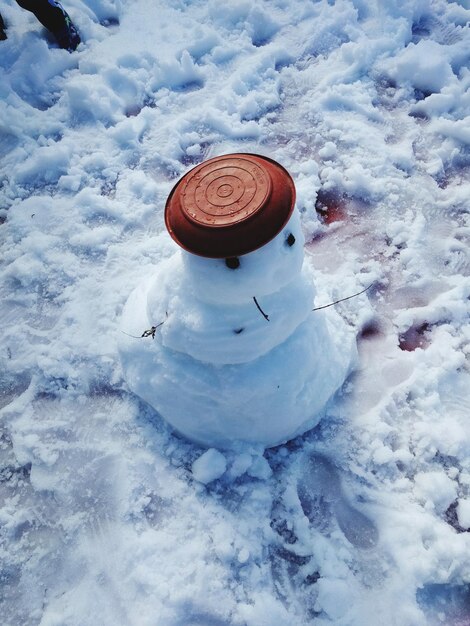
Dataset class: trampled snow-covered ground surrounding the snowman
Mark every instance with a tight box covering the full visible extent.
[0,0,470,626]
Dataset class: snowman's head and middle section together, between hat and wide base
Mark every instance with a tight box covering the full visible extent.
[147,212,314,365]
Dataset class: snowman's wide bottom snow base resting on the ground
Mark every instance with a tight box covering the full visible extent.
[119,282,355,449]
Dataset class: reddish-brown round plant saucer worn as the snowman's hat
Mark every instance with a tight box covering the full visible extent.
[165,153,295,259]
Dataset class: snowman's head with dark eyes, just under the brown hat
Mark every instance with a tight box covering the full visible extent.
[181,209,305,304]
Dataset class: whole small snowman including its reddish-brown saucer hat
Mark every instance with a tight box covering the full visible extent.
[119,154,355,449]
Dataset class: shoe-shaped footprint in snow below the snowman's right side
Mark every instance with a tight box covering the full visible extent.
[297,455,378,550]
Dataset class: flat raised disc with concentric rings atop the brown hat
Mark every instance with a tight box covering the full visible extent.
[181,158,272,226]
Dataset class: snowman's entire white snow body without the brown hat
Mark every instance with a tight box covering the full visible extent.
[120,210,355,449]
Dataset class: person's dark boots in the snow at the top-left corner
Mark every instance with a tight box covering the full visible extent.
[0,0,81,52]
